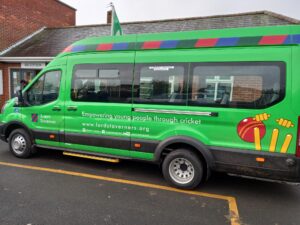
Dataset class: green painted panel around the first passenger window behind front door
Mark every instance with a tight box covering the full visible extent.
[64,52,134,157]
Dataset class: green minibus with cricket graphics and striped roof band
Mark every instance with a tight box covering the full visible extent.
[0,25,300,189]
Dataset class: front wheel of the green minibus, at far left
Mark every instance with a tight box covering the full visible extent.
[8,129,34,158]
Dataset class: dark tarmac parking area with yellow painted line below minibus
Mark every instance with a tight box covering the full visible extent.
[0,142,300,225]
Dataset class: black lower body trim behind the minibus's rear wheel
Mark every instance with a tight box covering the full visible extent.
[210,147,300,183]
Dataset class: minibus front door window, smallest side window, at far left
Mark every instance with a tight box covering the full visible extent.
[26,71,61,106]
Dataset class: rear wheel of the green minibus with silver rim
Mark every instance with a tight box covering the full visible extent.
[162,149,204,189]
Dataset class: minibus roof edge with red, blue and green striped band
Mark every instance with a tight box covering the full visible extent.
[61,25,300,55]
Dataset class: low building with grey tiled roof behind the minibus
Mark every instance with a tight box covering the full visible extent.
[0,9,300,105]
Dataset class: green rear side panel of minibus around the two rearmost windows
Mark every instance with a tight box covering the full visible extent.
[132,47,297,154]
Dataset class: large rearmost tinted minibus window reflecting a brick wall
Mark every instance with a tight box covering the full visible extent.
[189,63,285,108]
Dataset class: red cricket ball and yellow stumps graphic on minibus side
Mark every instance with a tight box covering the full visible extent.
[237,113,294,153]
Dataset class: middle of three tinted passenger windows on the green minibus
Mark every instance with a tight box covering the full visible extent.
[135,63,186,104]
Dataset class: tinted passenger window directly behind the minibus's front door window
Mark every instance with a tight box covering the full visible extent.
[71,64,133,103]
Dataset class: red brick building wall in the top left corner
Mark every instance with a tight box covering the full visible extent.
[0,0,76,51]
